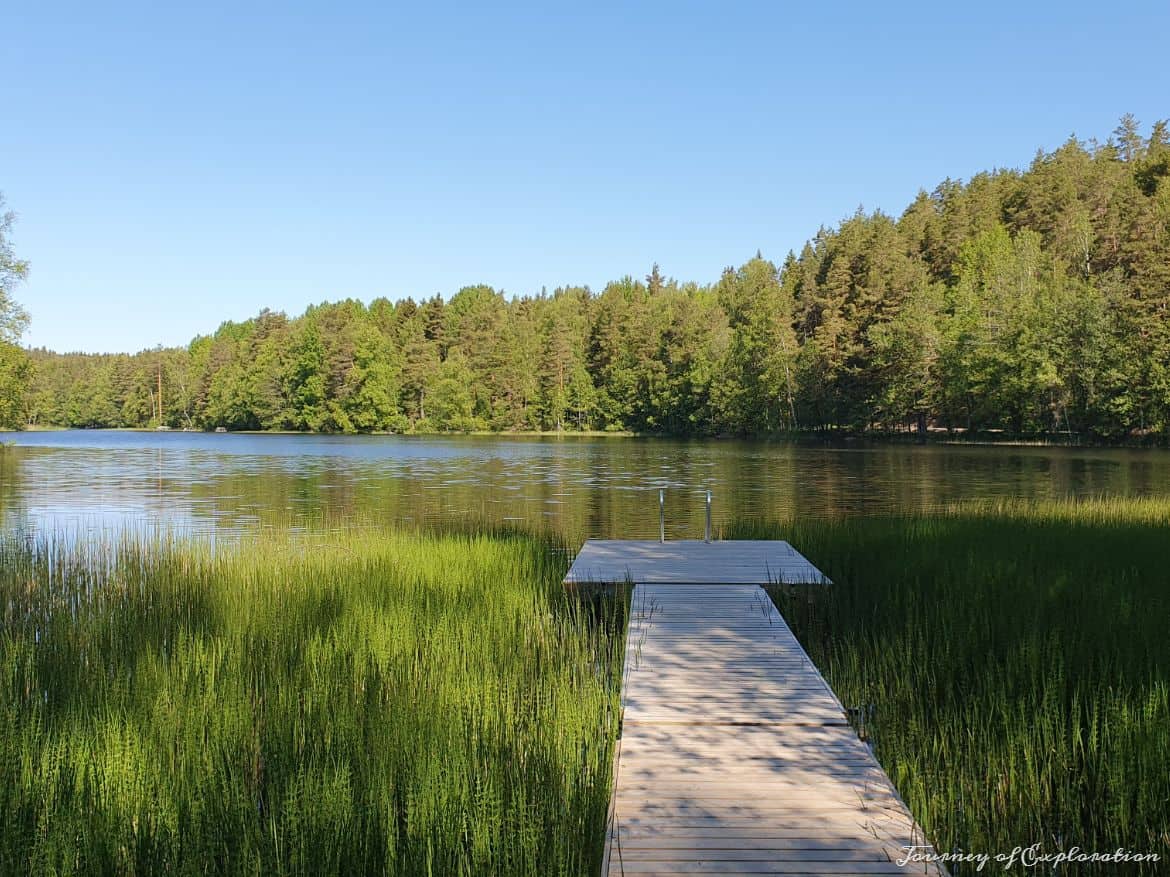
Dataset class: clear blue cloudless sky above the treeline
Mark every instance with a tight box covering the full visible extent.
[0,0,1170,351]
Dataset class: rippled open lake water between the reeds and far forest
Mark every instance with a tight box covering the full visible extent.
[0,430,1170,539]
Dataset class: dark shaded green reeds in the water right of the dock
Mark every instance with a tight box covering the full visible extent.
[735,502,1170,875]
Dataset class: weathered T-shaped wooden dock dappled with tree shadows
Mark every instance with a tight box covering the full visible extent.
[565,540,945,877]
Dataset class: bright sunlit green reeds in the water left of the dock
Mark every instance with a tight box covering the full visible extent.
[0,532,621,875]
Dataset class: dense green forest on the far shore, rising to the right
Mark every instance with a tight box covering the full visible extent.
[0,117,1170,440]
